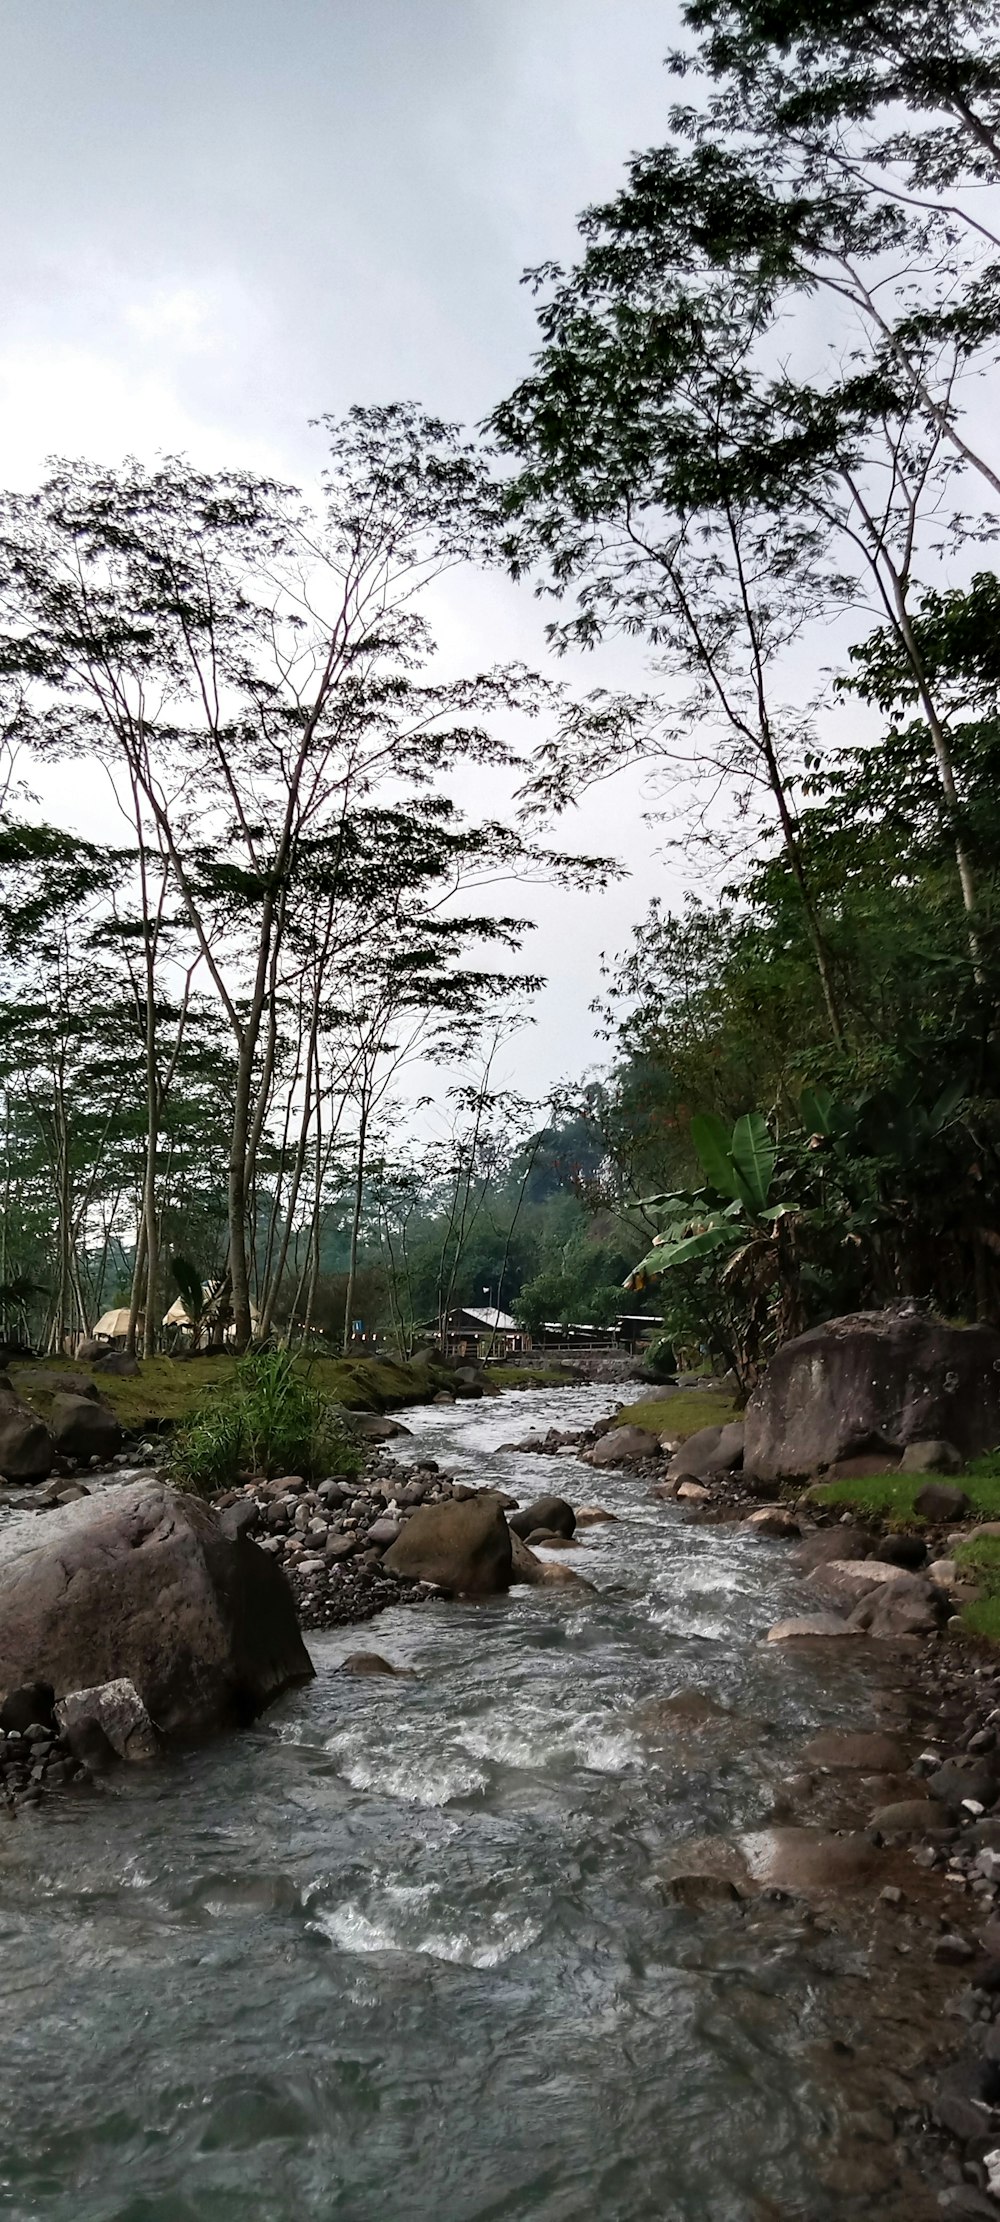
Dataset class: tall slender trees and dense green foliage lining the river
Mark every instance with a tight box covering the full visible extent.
[0,0,1000,1389]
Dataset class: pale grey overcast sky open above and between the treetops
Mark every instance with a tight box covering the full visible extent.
[0,0,711,1111]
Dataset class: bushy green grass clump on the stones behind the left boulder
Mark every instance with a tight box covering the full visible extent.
[171,1351,362,1498]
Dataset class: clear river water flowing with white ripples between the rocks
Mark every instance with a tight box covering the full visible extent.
[0,1389,946,2222]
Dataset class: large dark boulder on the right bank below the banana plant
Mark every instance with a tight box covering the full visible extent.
[744,1311,1000,1478]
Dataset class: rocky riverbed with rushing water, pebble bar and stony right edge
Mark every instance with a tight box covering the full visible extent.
[9,1391,1000,2222]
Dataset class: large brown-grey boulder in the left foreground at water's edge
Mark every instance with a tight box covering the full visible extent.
[0,1480,313,1740]
